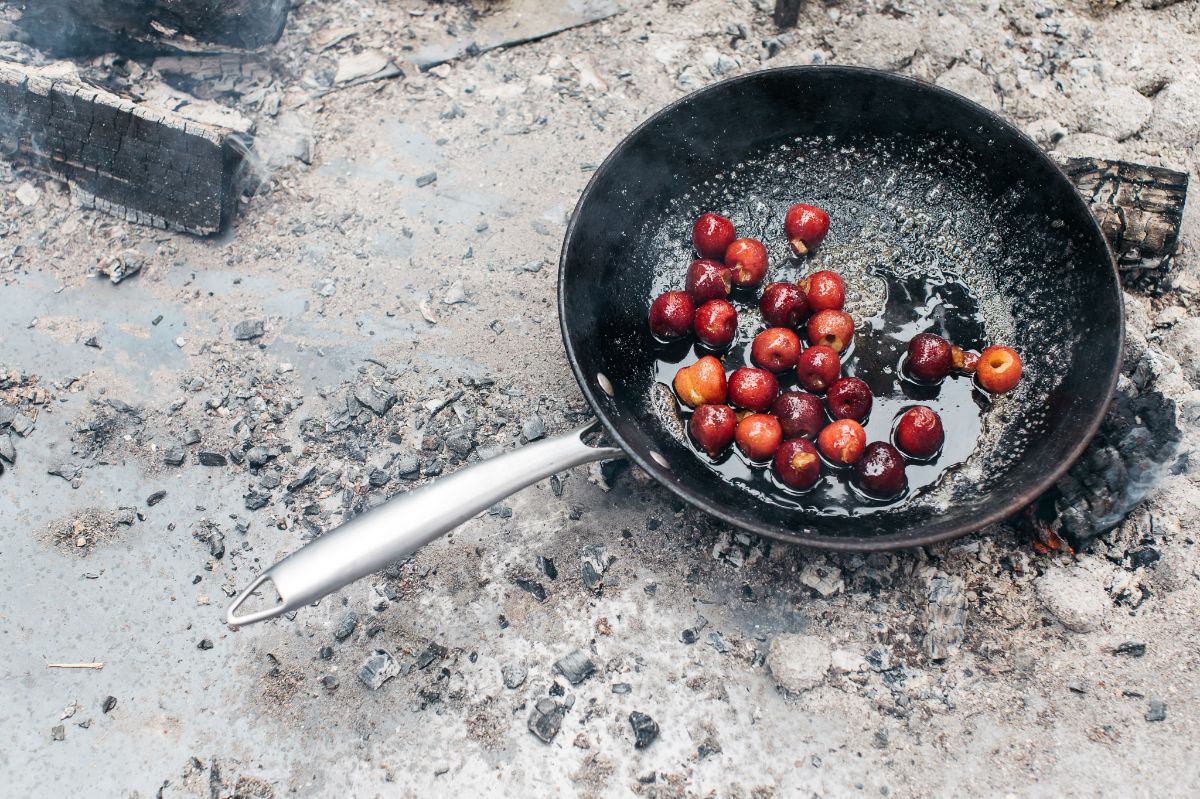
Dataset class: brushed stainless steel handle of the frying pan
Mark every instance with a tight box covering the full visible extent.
[226,422,624,625]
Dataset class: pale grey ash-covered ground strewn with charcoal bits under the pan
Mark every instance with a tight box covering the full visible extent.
[0,0,1200,797]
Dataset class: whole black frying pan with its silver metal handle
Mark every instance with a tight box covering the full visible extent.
[229,66,1123,624]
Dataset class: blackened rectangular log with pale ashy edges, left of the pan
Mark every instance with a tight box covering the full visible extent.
[0,64,252,235]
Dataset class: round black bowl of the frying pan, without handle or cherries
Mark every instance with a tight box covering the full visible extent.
[559,67,1122,548]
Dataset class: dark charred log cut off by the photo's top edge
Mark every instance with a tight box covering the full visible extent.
[18,0,290,56]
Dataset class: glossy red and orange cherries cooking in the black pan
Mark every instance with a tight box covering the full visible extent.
[649,204,1021,499]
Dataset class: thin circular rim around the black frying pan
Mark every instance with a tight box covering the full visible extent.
[558,65,1124,552]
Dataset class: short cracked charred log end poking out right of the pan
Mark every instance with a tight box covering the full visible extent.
[1063,158,1188,289]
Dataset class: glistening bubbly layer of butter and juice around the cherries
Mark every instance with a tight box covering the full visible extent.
[634,131,1057,516]
